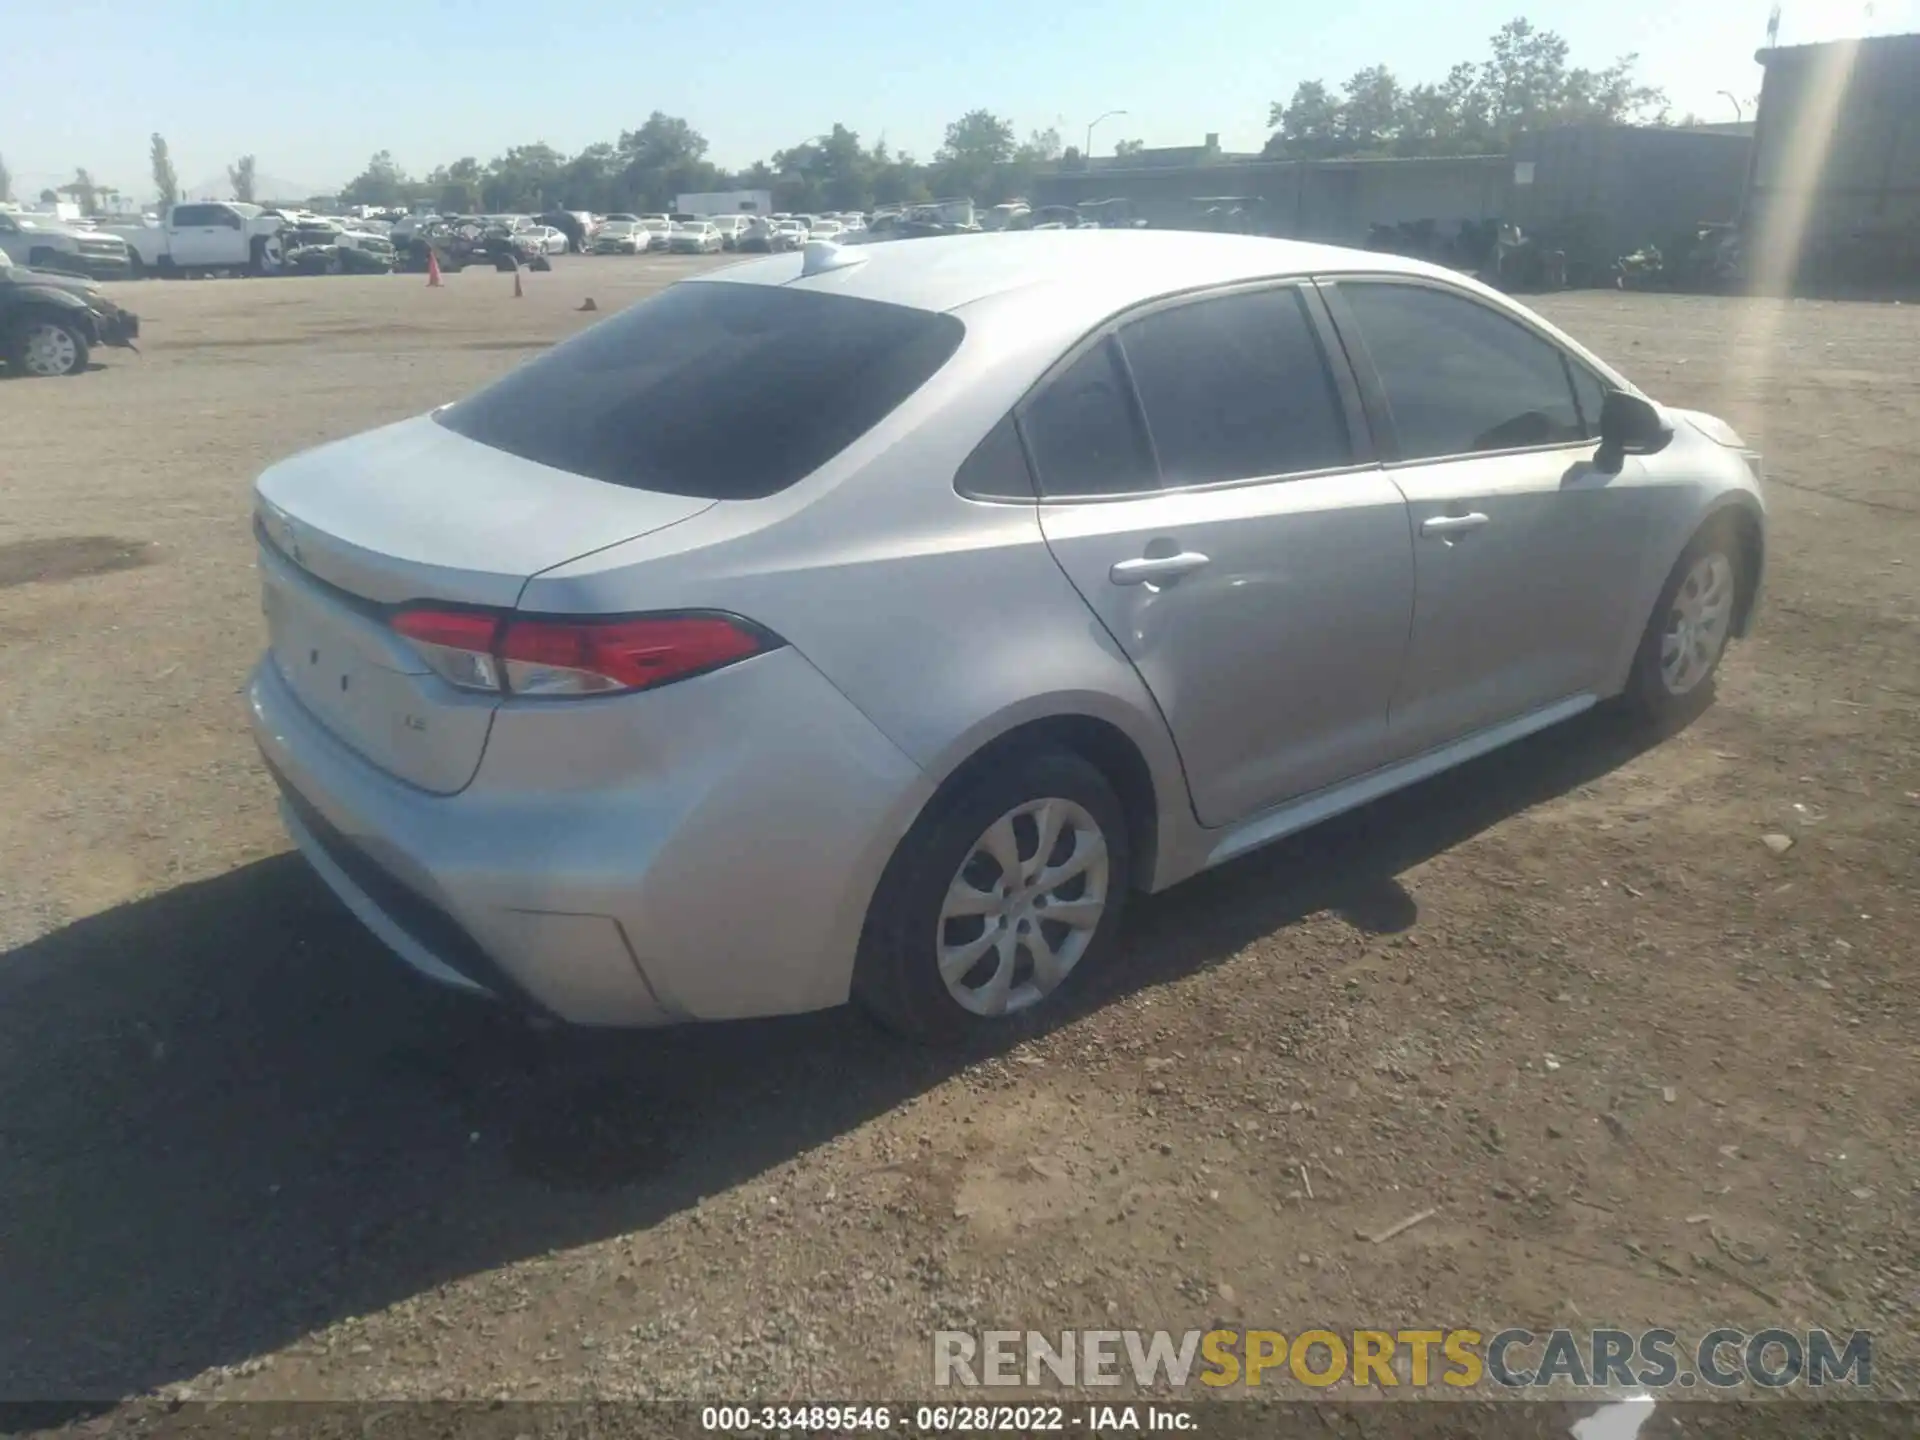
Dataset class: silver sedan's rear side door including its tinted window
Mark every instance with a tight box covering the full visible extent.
[1020,284,1413,826]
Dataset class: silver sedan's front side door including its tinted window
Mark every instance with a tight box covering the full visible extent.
[1329,276,1647,756]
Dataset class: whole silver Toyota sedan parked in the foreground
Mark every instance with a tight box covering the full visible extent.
[248,230,1766,1039]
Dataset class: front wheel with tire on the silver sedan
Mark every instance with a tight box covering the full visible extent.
[1622,524,1743,726]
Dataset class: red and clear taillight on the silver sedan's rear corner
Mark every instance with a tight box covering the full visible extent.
[394,609,780,695]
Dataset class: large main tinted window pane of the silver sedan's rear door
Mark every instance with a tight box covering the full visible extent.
[1119,288,1354,486]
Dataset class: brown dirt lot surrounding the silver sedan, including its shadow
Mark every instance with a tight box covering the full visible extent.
[0,259,1920,1398]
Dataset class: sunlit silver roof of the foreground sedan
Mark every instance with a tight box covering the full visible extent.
[695,228,1457,311]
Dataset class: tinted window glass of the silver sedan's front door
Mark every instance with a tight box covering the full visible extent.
[1340,282,1584,461]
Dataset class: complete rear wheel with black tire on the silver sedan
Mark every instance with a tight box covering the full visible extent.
[854,751,1133,1043]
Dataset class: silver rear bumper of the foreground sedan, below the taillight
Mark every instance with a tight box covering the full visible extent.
[248,649,924,1025]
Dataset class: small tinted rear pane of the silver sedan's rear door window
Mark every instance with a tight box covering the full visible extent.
[1020,340,1160,495]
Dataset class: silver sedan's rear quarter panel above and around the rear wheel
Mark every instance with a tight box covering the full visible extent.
[520,305,1192,885]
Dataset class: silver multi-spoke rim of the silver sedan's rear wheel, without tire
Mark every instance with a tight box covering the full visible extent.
[935,797,1110,1016]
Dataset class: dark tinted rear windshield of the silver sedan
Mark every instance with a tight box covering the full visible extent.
[434,280,966,499]
